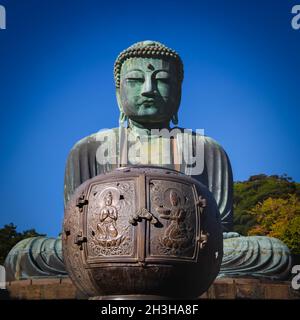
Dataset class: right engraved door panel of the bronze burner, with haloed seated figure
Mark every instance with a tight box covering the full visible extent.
[149,180,199,260]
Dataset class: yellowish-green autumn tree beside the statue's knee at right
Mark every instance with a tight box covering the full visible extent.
[249,194,300,254]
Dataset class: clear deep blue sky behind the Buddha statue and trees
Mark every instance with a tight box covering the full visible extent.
[0,0,300,236]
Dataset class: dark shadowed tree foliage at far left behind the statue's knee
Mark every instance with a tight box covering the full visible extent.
[0,223,44,264]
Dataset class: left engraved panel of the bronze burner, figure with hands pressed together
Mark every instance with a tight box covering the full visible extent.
[87,181,136,258]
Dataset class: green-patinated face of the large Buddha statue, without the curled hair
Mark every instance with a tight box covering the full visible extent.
[117,58,181,124]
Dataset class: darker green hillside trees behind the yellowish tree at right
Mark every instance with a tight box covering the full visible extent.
[234,174,300,235]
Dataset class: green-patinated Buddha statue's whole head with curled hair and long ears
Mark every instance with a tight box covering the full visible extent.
[114,41,183,127]
